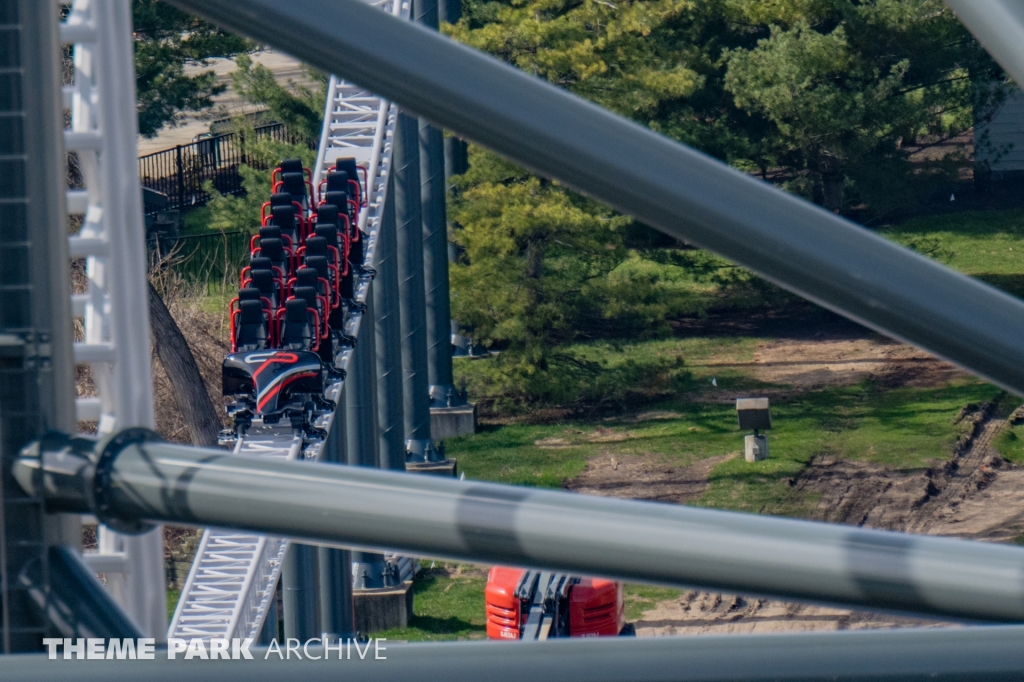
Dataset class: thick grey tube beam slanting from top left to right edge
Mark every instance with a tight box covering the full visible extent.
[170,0,1024,394]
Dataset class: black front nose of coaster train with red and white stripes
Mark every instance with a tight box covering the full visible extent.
[221,350,325,422]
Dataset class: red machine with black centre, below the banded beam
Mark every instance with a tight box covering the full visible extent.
[484,566,634,639]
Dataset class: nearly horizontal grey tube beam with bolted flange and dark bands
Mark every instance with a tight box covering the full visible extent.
[14,430,1024,622]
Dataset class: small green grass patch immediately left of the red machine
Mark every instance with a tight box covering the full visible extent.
[372,562,486,642]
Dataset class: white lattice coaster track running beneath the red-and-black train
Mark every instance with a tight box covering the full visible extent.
[168,0,414,639]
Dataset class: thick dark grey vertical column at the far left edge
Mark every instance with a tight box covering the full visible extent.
[0,0,86,653]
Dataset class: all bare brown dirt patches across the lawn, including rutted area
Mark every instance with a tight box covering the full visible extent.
[567,338,1024,636]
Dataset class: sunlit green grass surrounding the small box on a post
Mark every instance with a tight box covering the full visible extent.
[447,380,999,514]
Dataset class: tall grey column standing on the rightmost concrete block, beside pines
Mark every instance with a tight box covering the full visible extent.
[413,0,465,408]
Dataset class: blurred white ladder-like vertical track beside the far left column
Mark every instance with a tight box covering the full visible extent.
[60,0,167,641]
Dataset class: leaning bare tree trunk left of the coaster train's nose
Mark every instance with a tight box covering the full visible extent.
[150,284,220,445]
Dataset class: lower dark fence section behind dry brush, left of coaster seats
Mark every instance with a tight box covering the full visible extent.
[148,230,250,291]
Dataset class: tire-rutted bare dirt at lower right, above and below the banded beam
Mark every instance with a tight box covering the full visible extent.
[636,396,1024,636]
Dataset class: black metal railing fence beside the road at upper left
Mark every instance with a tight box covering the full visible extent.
[138,123,305,213]
